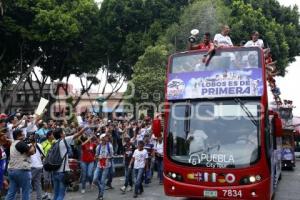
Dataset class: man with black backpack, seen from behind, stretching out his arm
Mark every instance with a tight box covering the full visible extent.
[44,128,84,200]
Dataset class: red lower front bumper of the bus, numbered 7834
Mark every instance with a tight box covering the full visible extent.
[164,176,271,200]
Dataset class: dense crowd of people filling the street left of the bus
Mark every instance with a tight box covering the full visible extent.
[0,113,163,200]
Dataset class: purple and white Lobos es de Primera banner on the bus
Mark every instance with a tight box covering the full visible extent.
[167,68,263,100]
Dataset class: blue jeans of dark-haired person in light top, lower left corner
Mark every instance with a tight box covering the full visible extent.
[5,169,31,200]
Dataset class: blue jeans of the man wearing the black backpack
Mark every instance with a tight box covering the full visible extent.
[53,172,66,200]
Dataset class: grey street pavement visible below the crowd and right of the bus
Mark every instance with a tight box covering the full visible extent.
[66,160,300,200]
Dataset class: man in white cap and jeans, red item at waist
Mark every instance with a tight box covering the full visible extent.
[96,133,114,200]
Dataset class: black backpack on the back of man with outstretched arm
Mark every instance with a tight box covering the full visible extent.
[44,139,68,172]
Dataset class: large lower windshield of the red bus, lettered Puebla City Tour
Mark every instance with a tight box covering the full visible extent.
[167,100,260,168]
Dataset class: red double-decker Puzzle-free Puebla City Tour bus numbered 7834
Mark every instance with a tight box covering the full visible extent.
[153,47,282,200]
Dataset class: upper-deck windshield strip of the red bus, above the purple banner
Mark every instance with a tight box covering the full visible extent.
[170,48,261,73]
